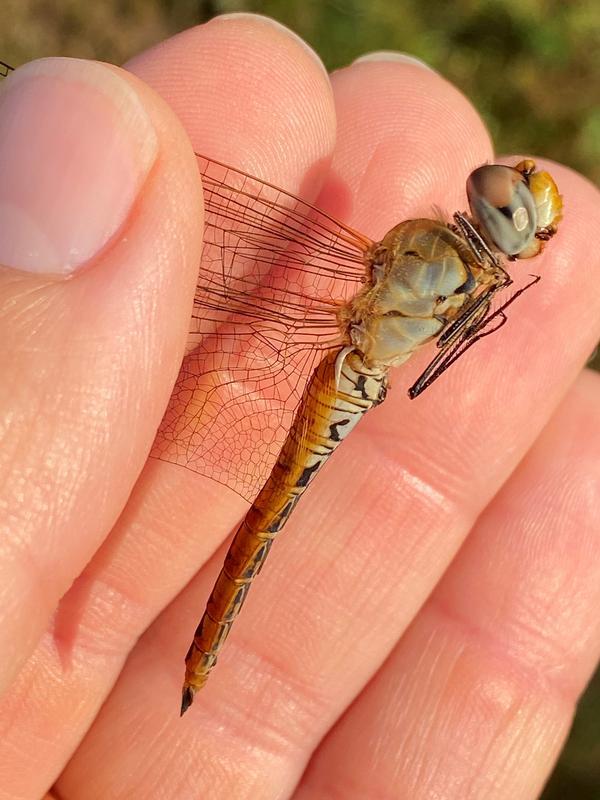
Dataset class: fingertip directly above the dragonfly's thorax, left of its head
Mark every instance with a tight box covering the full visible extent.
[332,54,493,231]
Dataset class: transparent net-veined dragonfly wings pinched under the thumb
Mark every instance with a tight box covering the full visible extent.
[151,156,372,499]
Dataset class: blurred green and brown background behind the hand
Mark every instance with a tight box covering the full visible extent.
[0,0,600,800]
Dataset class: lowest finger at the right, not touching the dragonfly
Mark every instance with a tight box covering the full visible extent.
[294,372,600,800]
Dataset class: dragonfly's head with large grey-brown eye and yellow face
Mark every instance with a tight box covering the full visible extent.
[467,159,562,258]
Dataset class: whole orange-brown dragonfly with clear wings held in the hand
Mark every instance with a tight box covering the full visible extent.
[2,59,562,714]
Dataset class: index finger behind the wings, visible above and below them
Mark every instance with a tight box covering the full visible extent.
[0,18,335,798]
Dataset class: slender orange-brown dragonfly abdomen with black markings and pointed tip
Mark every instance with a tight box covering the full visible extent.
[181,348,387,714]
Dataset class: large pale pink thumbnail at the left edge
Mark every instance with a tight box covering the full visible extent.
[0,58,158,275]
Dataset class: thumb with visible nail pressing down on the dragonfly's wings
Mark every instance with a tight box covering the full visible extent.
[0,59,202,689]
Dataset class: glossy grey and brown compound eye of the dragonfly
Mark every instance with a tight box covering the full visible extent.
[467,164,537,256]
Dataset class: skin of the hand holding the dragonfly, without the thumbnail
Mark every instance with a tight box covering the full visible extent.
[0,10,600,800]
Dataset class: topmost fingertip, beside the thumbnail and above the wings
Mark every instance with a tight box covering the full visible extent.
[127,14,336,195]
